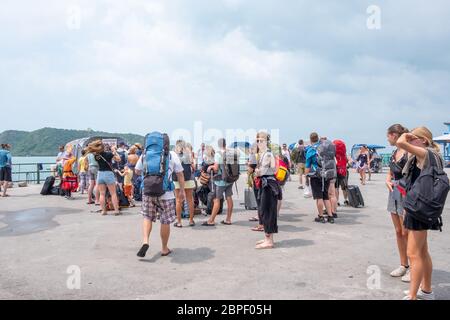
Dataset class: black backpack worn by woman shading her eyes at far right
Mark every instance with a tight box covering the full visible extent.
[404,150,449,231]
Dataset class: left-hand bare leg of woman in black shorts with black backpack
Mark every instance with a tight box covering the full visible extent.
[407,230,427,300]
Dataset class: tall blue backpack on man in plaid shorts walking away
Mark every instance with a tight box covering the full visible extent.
[143,132,174,197]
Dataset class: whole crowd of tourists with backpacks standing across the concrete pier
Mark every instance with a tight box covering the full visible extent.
[0,124,449,300]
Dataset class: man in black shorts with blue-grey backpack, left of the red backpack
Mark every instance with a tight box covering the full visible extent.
[306,132,336,223]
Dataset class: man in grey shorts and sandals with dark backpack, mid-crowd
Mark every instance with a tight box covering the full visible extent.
[202,138,239,226]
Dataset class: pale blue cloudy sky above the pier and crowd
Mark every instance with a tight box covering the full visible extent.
[0,0,450,149]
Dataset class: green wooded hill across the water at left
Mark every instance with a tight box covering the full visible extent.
[0,128,144,157]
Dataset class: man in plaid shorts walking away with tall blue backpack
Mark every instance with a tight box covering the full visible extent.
[135,132,185,258]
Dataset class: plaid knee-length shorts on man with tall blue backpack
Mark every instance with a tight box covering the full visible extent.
[141,195,177,224]
